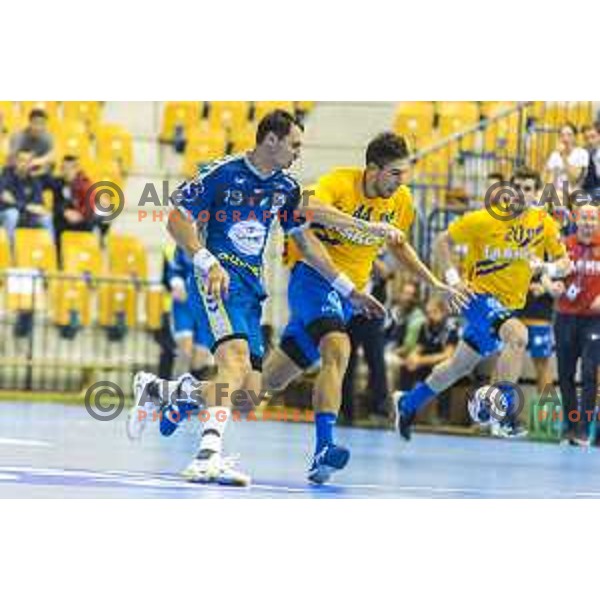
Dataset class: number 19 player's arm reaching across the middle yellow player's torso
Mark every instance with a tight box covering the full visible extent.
[290,227,385,318]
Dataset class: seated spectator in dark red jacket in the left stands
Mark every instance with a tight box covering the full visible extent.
[52,155,96,251]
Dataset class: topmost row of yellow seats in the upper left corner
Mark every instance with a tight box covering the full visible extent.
[0,100,102,134]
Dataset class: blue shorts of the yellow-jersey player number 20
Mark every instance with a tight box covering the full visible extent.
[462,294,514,356]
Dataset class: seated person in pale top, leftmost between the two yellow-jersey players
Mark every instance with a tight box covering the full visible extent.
[386,281,425,358]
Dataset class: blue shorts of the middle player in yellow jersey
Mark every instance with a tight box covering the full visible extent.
[280,262,354,369]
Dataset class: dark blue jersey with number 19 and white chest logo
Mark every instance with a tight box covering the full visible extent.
[172,155,304,297]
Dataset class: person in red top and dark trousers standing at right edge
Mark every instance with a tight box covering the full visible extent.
[552,205,600,446]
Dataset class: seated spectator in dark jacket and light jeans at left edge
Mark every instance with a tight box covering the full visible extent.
[0,151,53,242]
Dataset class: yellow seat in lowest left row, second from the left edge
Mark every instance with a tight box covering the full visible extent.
[48,277,92,327]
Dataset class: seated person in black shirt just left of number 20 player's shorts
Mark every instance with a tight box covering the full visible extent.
[399,297,458,422]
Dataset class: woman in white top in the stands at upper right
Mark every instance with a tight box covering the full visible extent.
[546,123,590,197]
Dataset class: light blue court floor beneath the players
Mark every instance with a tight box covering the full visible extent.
[0,402,600,499]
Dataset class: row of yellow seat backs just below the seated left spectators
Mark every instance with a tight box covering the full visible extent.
[0,228,148,279]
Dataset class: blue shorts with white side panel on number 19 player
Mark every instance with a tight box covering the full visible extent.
[188,272,265,371]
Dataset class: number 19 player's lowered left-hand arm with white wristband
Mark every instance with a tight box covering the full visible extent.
[167,210,229,297]
